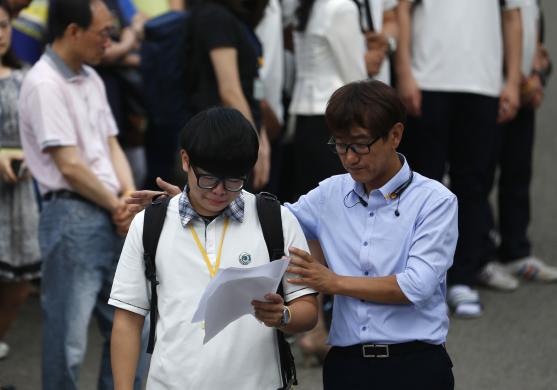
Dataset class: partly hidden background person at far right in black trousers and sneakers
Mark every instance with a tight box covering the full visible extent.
[479,2,557,291]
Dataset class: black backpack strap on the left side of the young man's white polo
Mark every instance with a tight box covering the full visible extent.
[143,197,170,354]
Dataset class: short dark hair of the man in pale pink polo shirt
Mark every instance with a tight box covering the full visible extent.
[48,0,98,43]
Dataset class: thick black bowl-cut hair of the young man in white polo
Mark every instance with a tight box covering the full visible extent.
[180,107,259,177]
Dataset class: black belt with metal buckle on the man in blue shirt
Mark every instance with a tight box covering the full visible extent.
[333,341,444,358]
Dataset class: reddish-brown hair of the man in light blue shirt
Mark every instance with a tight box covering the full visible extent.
[325,80,406,138]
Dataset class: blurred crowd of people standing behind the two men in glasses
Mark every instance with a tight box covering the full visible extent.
[0,0,557,389]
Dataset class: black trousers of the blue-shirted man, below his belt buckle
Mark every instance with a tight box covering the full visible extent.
[323,347,454,390]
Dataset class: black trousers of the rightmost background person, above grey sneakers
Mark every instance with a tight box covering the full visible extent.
[498,108,535,262]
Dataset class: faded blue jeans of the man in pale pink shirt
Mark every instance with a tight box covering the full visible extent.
[39,198,146,390]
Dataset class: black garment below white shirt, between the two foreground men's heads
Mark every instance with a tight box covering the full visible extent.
[294,115,346,199]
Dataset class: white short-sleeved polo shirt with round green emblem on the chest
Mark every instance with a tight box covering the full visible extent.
[109,192,315,390]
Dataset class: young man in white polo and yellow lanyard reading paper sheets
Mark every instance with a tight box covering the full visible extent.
[109,108,317,390]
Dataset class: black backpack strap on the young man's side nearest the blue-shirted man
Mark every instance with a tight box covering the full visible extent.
[256,192,298,390]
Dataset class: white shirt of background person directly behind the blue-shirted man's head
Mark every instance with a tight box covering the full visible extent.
[290,0,367,115]
